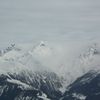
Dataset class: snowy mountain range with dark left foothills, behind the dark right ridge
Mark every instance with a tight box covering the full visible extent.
[0,41,100,100]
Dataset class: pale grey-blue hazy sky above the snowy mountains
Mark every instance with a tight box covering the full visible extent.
[0,0,100,45]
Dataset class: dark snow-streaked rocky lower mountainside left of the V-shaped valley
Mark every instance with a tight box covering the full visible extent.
[0,72,62,100]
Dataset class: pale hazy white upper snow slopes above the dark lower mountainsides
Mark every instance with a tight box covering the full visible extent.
[0,41,100,97]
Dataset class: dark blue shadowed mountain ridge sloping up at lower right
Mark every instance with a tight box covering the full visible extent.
[61,69,100,100]
